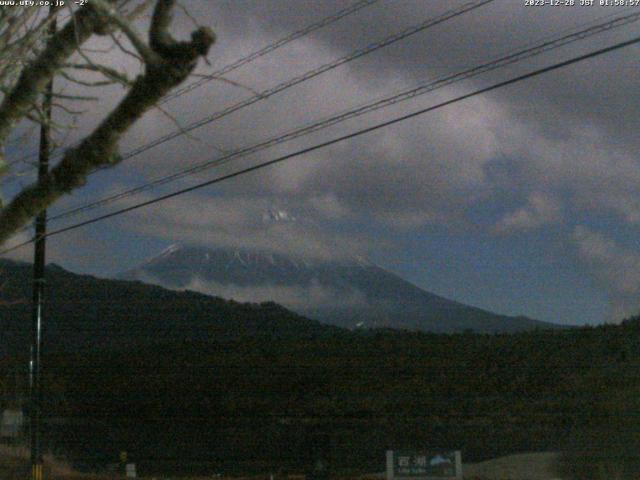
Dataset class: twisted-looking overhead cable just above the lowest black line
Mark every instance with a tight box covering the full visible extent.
[50,8,640,221]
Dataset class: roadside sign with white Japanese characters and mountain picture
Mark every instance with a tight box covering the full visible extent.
[387,450,462,480]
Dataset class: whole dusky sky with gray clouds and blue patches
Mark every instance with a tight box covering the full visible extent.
[4,0,640,323]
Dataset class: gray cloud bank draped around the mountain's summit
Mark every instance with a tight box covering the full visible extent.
[109,188,386,259]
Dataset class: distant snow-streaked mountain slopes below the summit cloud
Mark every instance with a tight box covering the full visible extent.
[121,246,558,333]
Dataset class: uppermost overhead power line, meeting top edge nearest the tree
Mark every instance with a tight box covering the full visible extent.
[2,0,380,171]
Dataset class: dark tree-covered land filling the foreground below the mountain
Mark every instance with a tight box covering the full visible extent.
[0,260,640,480]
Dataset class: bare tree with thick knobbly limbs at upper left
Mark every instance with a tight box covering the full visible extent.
[0,0,215,245]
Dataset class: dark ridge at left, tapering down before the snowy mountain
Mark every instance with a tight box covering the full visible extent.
[0,260,337,354]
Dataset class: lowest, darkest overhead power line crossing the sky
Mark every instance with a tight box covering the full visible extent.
[0,31,640,255]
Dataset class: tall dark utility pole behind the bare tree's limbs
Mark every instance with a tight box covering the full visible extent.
[29,7,57,480]
